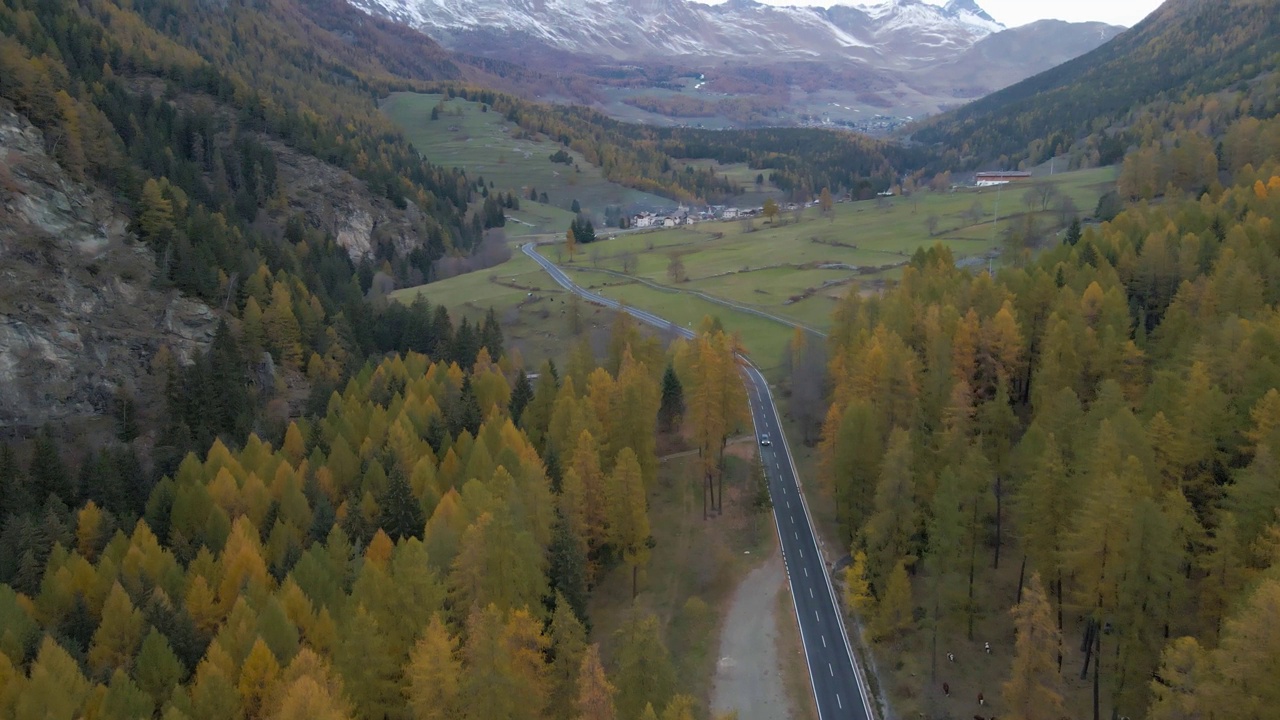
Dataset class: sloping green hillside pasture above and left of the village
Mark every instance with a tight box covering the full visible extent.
[381,92,676,229]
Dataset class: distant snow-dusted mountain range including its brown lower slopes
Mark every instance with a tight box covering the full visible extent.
[352,0,1114,124]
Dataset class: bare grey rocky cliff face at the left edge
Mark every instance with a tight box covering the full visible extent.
[0,101,218,428]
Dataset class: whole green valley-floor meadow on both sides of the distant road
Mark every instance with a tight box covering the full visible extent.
[396,168,1116,370]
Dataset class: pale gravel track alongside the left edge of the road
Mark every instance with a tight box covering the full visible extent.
[712,548,795,720]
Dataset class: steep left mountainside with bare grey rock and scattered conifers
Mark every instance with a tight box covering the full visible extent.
[0,0,484,430]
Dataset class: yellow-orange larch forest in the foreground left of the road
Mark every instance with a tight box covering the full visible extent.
[0,302,746,720]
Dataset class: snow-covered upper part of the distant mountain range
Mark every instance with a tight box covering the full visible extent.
[351,0,1004,63]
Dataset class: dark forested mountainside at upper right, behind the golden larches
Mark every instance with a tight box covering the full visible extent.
[913,0,1280,165]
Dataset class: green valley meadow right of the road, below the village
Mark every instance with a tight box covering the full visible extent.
[544,168,1115,368]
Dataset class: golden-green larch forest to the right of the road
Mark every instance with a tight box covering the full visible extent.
[819,103,1280,720]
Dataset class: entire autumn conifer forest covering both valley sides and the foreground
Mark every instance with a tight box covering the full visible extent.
[0,0,1280,720]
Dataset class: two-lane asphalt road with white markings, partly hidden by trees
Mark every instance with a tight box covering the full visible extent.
[521,243,873,720]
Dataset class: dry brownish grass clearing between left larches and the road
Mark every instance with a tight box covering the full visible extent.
[590,437,778,707]
